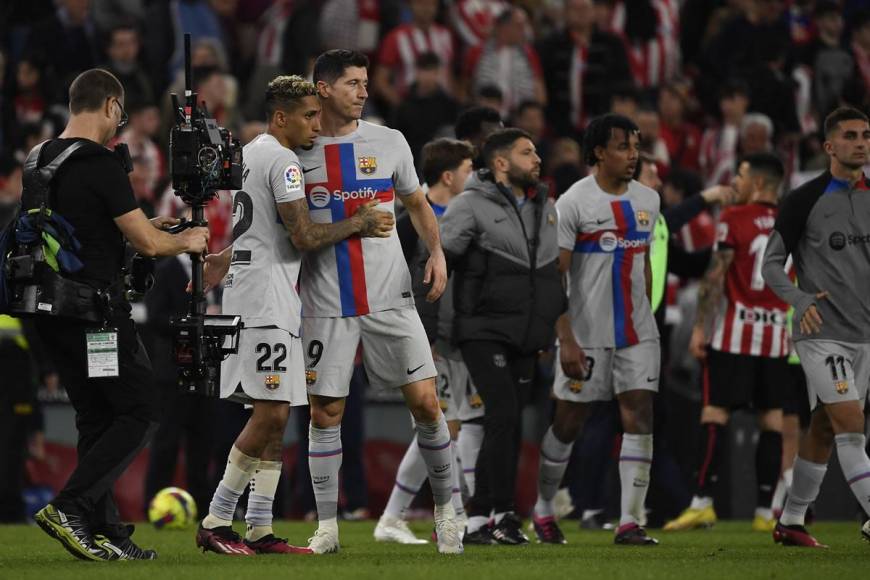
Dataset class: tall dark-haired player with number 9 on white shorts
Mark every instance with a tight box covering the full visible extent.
[297,50,462,554]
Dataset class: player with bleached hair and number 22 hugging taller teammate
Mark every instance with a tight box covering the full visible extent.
[196,76,394,556]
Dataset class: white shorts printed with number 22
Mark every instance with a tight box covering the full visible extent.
[221,326,308,407]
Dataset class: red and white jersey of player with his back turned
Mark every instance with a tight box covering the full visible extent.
[710,203,790,358]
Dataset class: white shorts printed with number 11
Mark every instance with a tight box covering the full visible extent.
[794,339,870,409]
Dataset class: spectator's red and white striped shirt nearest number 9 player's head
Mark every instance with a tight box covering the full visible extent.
[378,24,455,95]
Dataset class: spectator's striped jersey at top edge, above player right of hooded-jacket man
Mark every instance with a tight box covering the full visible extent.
[610,0,680,89]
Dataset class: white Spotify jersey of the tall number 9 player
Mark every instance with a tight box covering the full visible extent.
[297,121,420,317]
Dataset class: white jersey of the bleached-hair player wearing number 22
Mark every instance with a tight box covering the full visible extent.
[223,133,305,337]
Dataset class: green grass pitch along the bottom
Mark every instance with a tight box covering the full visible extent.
[0,521,870,580]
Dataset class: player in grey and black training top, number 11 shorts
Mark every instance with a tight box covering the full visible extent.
[762,107,870,547]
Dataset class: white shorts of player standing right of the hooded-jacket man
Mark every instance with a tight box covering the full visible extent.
[553,339,661,403]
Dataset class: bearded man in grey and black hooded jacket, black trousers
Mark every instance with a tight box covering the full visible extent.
[441,129,565,544]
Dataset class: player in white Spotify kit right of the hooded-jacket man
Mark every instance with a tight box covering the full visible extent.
[533,114,660,545]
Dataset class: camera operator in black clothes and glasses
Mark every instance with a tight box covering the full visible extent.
[22,69,208,560]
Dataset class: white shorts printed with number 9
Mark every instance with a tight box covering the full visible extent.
[302,307,437,397]
